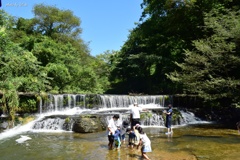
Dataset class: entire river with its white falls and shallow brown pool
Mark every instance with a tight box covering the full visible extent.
[0,95,240,160]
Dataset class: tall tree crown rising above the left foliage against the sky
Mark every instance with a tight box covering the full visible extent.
[33,4,81,37]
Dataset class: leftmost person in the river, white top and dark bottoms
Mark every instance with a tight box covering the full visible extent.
[107,114,120,149]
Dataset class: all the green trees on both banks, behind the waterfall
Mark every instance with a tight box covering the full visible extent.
[0,0,240,123]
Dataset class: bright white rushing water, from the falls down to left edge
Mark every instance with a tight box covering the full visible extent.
[0,95,208,140]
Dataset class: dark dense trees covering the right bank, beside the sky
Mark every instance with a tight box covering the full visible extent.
[110,0,240,106]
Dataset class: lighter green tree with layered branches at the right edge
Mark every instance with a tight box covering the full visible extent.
[168,6,240,107]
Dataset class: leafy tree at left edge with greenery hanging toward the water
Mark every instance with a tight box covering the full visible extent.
[0,15,48,125]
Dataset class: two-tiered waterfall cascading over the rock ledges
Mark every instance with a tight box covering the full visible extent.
[0,94,208,140]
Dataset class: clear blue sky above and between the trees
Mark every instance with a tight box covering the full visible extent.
[1,0,142,56]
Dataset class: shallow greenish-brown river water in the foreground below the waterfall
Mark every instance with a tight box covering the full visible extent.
[0,124,240,160]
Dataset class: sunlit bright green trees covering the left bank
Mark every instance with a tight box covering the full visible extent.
[0,4,109,120]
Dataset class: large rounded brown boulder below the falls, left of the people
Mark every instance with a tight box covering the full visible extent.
[72,115,106,133]
